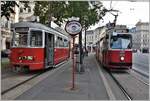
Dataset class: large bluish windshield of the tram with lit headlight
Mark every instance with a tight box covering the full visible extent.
[110,34,132,49]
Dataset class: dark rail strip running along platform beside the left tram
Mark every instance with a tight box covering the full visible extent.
[1,61,67,95]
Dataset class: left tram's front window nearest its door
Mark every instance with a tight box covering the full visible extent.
[30,31,42,47]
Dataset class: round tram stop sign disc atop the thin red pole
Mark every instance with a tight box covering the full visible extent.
[65,20,82,36]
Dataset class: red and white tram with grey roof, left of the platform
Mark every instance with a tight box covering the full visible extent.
[10,22,70,70]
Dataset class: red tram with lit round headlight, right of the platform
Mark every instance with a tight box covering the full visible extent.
[96,26,132,69]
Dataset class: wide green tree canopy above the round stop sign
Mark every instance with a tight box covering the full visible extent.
[34,1,106,28]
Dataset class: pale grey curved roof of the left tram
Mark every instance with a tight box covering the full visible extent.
[12,21,67,37]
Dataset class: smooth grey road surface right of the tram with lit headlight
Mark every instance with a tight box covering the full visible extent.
[133,52,149,76]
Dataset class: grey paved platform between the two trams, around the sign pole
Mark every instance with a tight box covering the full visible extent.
[16,54,109,100]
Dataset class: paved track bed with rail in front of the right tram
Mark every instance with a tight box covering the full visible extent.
[109,71,149,100]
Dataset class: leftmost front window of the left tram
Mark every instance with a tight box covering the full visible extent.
[13,32,28,47]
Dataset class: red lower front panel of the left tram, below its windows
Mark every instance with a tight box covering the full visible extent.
[10,48,44,70]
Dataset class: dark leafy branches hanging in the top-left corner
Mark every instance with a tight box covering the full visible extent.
[1,1,29,20]
